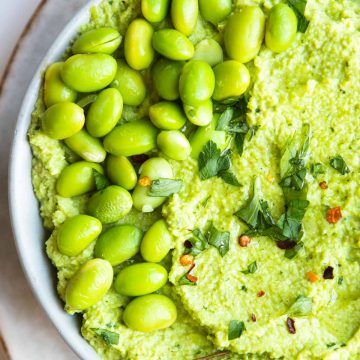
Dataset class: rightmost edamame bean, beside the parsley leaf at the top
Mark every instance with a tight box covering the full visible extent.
[265,3,298,53]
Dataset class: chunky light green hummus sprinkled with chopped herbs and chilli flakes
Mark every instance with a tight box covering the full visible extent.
[29,0,360,360]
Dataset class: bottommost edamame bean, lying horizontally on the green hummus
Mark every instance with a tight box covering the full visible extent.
[123,294,177,332]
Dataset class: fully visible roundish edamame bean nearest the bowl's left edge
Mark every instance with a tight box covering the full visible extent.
[42,102,85,140]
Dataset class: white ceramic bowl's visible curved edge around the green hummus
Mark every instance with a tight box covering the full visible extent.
[9,0,110,360]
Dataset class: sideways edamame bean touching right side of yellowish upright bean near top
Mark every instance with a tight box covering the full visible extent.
[152,29,194,60]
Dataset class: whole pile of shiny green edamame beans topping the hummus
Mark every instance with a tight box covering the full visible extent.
[42,0,297,332]
